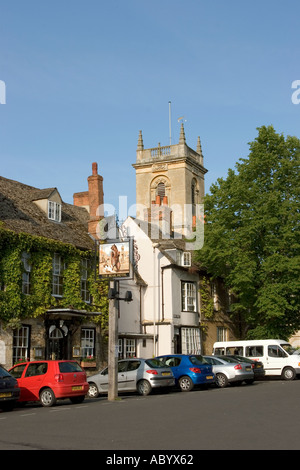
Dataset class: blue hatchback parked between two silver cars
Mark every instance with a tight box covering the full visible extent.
[156,354,215,392]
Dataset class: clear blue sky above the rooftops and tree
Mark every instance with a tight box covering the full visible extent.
[0,0,300,217]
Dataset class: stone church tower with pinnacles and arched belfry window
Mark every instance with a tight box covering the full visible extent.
[133,123,207,238]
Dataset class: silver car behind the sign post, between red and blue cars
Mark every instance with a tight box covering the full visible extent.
[87,358,175,398]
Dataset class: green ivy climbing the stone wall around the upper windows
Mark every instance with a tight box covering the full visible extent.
[0,225,108,329]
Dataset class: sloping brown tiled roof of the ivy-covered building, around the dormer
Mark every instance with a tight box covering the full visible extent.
[0,176,94,249]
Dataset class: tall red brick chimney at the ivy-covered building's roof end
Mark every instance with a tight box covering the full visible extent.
[73,162,104,238]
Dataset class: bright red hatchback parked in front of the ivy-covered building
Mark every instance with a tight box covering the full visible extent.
[9,361,89,406]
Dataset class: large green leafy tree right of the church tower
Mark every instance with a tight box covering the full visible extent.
[196,126,300,339]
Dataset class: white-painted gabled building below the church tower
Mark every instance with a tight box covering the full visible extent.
[119,217,201,357]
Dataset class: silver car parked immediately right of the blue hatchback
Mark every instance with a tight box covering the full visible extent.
[204,356,254,388]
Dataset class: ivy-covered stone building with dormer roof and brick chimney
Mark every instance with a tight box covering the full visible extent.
[0,163,108,370]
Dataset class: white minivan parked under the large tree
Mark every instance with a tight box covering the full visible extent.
[213,339,300,380]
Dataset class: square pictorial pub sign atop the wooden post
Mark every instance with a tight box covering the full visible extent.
[99,239,132,279]
